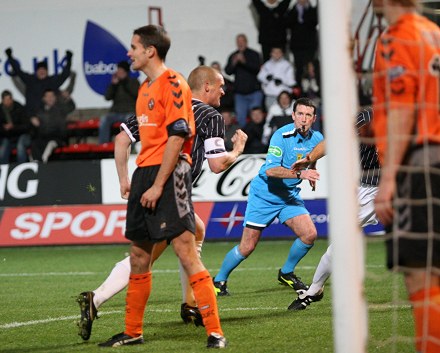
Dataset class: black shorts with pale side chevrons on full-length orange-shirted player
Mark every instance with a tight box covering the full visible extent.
[125,160,195,243]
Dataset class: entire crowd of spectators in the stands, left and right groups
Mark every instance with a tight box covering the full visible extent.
[0,0,322,164]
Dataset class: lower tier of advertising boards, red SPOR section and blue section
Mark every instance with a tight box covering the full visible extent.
[0,200,381,246]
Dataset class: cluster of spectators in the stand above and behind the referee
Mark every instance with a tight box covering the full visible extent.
[218,0,323,153]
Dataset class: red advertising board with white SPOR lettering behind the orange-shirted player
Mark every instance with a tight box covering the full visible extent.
[0,202,213,246]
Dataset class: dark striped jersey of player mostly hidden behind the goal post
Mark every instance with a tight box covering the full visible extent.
[356,108,380,186]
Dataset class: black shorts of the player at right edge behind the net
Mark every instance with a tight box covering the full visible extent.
[386,149,440,270]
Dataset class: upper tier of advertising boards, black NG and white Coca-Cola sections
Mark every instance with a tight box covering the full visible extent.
[0,155,328,207]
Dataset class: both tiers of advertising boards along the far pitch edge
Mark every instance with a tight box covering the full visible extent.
[0,155,381,246]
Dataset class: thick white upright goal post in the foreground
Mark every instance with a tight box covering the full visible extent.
[318,0,367,353]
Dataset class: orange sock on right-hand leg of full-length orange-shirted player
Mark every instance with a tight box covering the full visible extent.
[189,270,223,336]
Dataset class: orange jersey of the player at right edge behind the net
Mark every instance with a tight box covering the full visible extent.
[373,13,440,162]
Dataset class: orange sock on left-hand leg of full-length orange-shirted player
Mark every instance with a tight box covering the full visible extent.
[124,272,151,337]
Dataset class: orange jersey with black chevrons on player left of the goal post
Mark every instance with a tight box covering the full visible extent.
[136,69,195,167]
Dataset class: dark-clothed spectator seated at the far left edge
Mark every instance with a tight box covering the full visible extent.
[0,90,31,164]
